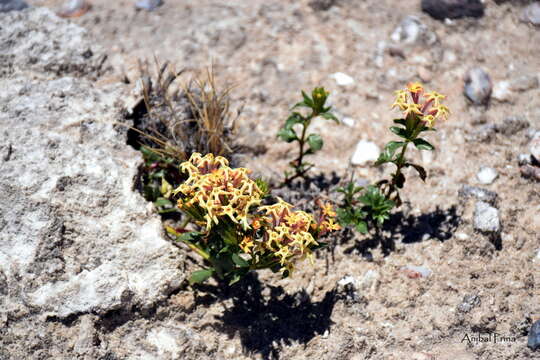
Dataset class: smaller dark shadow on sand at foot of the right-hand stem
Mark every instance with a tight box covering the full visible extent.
[345,205,461,259]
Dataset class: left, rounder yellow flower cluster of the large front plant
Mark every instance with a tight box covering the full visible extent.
[175,153,262,230]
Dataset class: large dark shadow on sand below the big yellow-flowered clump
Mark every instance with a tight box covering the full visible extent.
[197,274,338,359]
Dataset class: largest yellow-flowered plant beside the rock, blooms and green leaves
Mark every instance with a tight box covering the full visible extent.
[167,153,340,284]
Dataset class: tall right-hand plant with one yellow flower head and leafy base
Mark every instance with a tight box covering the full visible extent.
[337,83,449,234]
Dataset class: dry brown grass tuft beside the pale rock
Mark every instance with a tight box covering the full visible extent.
[128,60,235,161]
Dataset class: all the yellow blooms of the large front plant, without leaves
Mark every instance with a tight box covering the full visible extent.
[175,153,340,274]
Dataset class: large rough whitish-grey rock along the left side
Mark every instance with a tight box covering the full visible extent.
[0,8,184,359]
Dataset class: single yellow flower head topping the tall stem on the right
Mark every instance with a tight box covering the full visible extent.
[392,83,449,127]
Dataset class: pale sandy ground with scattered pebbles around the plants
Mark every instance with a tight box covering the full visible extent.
[28,0,540,359]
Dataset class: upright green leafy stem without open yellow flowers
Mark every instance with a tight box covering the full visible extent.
[277,87,338,185]
